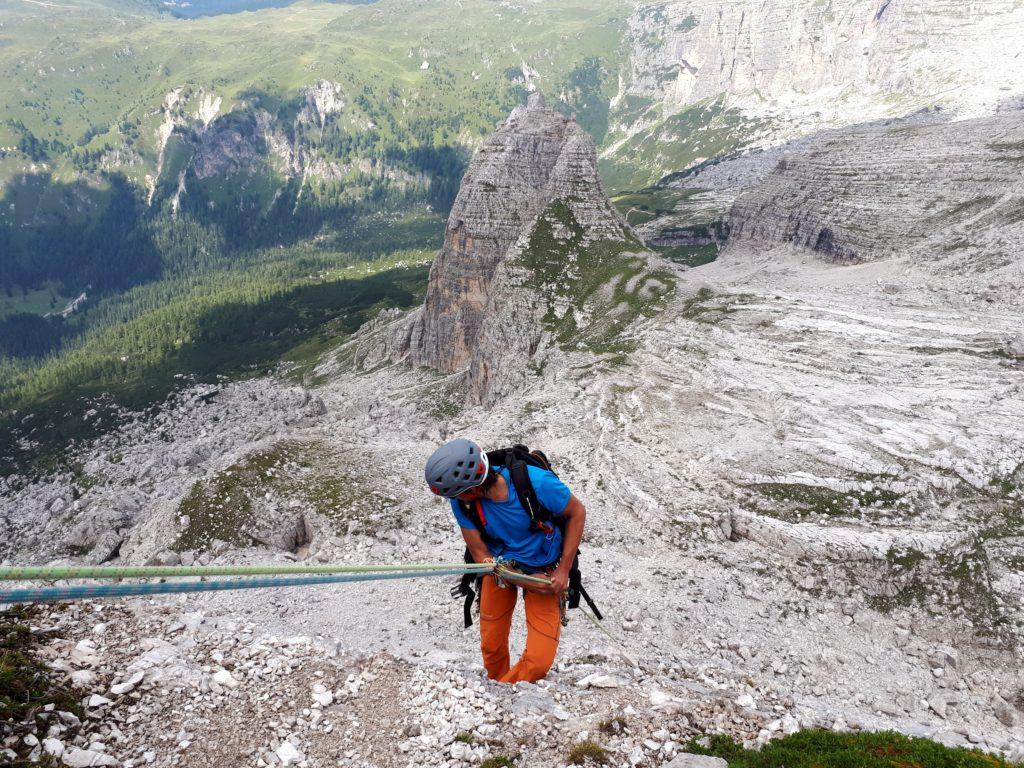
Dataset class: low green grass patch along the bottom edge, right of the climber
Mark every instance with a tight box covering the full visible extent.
[686,730,1014,768]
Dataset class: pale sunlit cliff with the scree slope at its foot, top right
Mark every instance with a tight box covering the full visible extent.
[602,0,1024,188]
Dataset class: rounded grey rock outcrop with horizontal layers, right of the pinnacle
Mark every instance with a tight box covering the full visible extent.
[729,112,1024,270]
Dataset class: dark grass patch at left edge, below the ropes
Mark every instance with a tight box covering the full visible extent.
[0,607,82,724]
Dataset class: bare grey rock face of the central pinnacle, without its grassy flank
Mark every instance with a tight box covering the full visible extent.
[410,93,625,373]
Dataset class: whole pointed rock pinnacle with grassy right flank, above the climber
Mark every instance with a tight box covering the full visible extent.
[395,93,672,403]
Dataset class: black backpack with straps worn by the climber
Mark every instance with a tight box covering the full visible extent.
[452,443,604,627]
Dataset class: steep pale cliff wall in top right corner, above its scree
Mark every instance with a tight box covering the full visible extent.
[625,0,1024,131]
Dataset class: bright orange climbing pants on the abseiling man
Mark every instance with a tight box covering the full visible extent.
[480,575,562,683]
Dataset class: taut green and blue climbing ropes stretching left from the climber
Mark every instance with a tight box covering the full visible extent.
[0,563,495,603]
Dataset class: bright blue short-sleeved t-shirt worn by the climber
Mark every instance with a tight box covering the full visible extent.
[452,467,571,567]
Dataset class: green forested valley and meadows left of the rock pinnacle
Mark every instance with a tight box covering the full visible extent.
[0,0,629,469]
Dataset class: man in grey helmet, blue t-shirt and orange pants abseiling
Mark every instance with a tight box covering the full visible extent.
[424,439,589,683]
